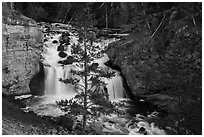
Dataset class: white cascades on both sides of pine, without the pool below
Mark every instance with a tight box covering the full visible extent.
[42,31,125,100]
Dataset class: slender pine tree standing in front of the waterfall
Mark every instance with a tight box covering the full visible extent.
[57,3,115,130]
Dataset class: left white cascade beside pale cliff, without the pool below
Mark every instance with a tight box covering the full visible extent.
[42,33,76,99]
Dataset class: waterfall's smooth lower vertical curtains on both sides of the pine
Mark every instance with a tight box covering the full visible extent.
[44,59,125,100]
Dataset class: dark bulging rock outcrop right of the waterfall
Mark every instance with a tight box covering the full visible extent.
[107,34,202,113]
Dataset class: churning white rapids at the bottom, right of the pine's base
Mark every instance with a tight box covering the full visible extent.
[95,114,166,135]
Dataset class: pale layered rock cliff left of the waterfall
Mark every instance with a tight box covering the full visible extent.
[2,3,43,94]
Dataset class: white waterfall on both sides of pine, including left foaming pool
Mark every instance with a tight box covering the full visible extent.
[22,26,125,116]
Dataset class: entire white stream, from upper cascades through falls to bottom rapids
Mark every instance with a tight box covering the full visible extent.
[16,23,166,135]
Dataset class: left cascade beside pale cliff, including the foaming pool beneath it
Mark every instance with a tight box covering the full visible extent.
[18,35,77,117]
